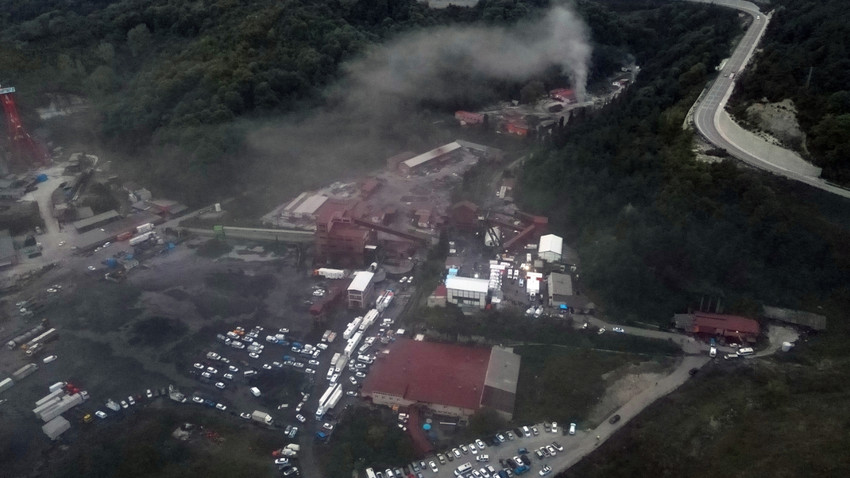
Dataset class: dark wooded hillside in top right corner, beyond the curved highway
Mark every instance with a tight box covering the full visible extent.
[731,0,850,185]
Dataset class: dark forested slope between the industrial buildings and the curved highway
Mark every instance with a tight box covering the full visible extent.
[521,2,850,324]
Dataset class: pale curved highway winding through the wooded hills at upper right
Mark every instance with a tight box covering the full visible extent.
[688,0,850,198]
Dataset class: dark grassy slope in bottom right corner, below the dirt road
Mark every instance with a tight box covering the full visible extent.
[563,361,850,478]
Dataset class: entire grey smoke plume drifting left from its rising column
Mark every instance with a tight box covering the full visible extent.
[249,6,591,189]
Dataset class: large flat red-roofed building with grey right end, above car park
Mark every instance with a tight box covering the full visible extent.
[361,339,521,420]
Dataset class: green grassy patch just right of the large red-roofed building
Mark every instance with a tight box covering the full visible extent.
[514,346,639,423]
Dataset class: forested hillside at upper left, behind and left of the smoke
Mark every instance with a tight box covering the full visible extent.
[0,0,588,202]
